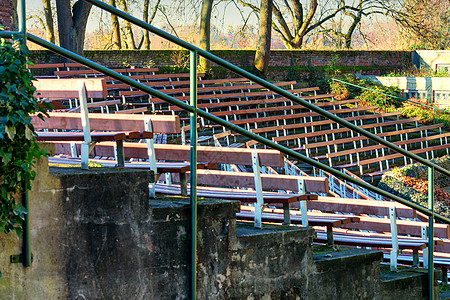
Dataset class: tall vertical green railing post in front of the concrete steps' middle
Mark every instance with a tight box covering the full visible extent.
[189,51,197,300]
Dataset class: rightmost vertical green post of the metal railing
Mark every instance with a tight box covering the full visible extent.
[428,167,434,299]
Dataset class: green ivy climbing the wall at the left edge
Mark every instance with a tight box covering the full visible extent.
[0,34,45,236]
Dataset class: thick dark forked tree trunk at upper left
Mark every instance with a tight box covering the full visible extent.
[56,0,92,55]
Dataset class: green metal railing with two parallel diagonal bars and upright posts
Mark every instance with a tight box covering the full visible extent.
[2,0,450,299]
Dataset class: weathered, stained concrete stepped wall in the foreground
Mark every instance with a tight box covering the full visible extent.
[0,156,436,300]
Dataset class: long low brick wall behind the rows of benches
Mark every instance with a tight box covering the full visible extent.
[30,50,411,81]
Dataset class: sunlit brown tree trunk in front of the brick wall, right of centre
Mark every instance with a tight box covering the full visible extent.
[255,0,273,77]
